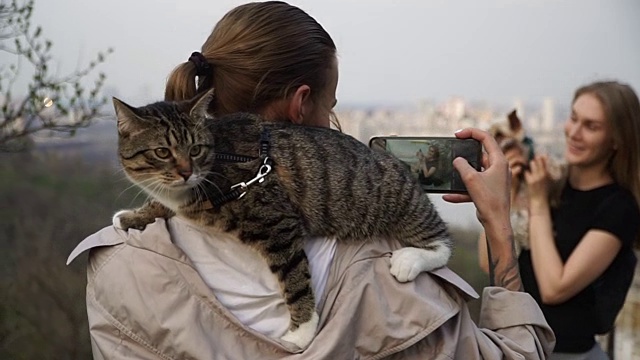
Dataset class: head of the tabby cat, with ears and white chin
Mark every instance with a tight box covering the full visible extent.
[114,90,214,201]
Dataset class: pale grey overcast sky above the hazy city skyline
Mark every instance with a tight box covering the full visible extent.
[8,0,640,104]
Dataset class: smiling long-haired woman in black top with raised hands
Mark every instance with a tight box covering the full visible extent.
[519,81,640,359]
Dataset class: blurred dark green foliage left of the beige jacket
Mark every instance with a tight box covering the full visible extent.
[0,152,142,359]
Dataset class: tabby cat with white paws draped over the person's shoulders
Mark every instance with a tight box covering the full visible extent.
[113,90,452,348]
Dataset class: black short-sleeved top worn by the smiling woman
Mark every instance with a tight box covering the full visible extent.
[519,183,640,353]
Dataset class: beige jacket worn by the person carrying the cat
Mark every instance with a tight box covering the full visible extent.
[69,220,555,360]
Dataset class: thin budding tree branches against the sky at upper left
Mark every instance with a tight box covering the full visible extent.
[0,0,113,152]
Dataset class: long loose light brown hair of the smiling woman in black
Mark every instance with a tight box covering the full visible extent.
[573,81,640,247]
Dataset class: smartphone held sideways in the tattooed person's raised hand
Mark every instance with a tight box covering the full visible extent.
[369,136,482,194]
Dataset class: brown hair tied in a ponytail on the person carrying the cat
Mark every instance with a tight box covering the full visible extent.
[165,1,336,121]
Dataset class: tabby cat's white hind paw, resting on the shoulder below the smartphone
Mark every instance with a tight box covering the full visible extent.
[391,246,451,282]
